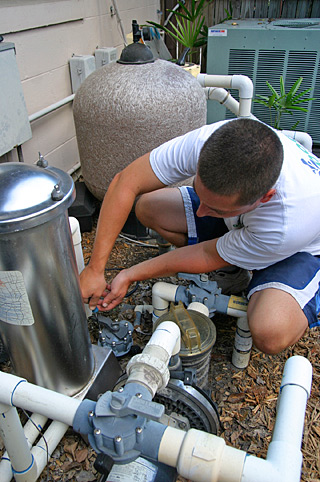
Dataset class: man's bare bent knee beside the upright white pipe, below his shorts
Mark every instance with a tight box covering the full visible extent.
[248,288,308,355]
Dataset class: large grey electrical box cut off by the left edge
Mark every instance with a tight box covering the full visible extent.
[0,42,32,156]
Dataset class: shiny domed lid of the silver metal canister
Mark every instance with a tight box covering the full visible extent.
[0,162,75,233]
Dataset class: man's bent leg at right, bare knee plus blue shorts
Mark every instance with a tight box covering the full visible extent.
[248,252,320,354]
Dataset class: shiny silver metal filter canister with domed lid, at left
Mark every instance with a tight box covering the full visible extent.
[0,163,94,395]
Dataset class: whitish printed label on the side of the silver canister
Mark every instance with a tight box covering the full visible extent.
[0,271,34,325]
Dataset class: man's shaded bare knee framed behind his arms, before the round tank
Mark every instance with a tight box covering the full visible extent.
[136,188,188,247]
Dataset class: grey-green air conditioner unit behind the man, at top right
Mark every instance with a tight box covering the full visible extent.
[207,18,320,144]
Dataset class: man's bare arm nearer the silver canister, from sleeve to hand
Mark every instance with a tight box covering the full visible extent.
[80,154,164,309]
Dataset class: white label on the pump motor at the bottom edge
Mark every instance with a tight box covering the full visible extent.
[107,457,158,482]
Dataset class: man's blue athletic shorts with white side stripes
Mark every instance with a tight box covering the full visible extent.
[179,186,320,328]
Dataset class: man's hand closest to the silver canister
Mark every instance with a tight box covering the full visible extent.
[80,264,107,310]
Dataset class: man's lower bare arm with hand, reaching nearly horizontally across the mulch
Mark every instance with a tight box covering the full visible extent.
[100,239,230,311]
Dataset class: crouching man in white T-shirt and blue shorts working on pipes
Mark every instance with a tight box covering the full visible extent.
[81,119,320,354]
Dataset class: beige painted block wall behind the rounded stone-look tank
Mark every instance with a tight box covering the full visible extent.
[0,0,160,171]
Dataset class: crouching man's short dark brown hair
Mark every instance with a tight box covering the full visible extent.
[198,119,283,206]
